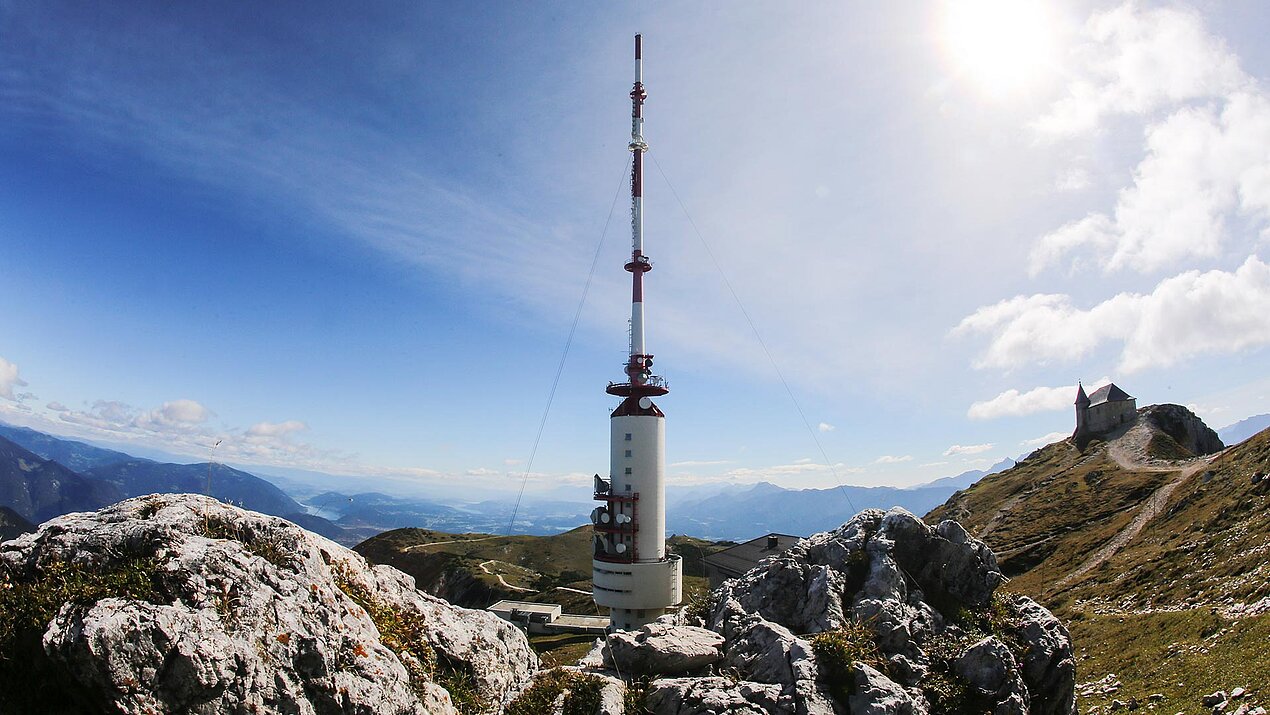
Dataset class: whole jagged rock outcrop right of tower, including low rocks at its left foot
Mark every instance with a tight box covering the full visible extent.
[587,508,1076,715]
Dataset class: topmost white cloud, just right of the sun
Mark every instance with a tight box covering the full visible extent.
[1034,3,1250,136]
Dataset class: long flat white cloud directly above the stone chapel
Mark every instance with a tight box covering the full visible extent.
[953,255,1270,372]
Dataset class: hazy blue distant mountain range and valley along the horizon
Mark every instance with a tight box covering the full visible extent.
[0,424,1015,545]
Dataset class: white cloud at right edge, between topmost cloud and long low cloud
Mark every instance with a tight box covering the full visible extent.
[1029,93,1270,276]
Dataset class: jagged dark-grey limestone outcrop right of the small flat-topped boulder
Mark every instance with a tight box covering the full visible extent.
[706,508,1076,715]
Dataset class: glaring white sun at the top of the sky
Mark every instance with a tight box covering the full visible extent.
[942,0,1054,95]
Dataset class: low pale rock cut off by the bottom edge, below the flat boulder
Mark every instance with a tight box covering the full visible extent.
[644,677,794,715]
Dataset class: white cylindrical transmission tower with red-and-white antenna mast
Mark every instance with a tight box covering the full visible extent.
[591,34,683,630]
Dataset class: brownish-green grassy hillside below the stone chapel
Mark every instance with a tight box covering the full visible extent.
[927,432,1270,712]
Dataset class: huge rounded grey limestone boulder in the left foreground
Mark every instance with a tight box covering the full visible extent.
[0,495,537,715]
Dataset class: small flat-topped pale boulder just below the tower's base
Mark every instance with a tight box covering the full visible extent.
[605,621,724,676]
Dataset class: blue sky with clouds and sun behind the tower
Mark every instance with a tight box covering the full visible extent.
[0,0,1270,493]
